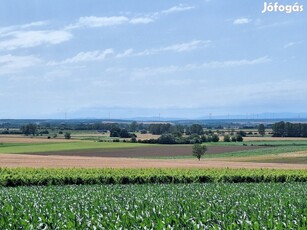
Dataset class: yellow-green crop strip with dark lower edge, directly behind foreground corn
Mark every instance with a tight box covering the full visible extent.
[0,168,307,186]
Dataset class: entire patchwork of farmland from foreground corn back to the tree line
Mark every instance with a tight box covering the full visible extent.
[0,125,307,229]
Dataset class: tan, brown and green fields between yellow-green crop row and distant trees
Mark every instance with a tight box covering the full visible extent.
[0,132,307,168]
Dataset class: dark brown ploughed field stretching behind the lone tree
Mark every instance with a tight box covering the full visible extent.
[22,145,263,158]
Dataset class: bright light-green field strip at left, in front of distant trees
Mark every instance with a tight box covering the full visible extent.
[0,142,147,154]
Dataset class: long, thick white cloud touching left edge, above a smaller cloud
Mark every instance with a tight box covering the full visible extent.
[0,30,73,50]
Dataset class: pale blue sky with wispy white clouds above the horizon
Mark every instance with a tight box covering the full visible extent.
[0,0,307,119]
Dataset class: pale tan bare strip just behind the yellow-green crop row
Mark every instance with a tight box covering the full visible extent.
[0,154,307,169]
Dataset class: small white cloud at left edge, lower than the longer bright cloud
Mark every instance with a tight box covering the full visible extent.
[0,54,41,74]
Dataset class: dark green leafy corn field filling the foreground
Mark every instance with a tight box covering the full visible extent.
[0,183,307,230]
